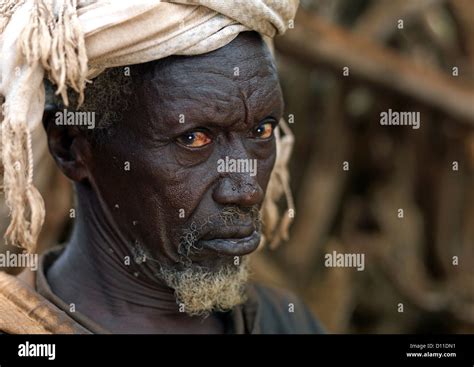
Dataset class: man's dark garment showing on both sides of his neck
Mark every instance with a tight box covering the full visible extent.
[6,248,323,334]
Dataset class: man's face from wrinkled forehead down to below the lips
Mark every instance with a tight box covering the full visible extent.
[84,33,283,269]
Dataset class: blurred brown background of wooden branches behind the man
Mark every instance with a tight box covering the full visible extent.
[0,0,474,333]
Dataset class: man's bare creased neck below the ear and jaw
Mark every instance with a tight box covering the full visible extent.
[47,185,223,333]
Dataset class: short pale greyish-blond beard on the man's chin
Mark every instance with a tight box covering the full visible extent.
[161,257,249,317]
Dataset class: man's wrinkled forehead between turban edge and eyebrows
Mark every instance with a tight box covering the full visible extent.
[128,32,282,131]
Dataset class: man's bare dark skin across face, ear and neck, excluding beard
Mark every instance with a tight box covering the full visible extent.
[44,33,283,333]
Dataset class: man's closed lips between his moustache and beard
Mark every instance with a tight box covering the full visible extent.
[198,231,261,256]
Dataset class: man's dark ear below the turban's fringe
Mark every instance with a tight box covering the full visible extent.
[43,105,91,182]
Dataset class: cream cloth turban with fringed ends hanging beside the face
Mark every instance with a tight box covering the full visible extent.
[0,0,298,251]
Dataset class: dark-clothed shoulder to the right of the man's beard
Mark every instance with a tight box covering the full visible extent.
[246,283,324,334]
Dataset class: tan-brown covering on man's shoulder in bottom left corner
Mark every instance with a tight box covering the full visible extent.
[0,271,89,334]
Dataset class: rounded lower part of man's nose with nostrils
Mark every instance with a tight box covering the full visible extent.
[212,172,264,207]
